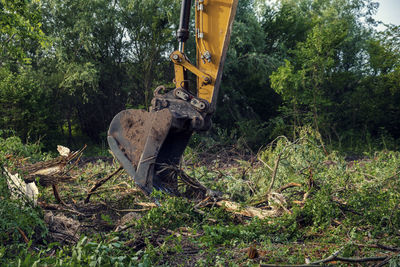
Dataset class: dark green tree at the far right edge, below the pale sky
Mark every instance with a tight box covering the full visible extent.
[352,26,400,138]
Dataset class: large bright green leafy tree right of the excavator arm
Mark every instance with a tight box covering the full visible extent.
[271,0,376,142]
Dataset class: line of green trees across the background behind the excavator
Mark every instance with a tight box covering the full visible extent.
[0,0,400,153]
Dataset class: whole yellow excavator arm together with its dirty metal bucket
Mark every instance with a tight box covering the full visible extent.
[107,0,238,194]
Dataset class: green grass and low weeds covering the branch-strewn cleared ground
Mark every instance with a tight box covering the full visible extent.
[0,128,400,266]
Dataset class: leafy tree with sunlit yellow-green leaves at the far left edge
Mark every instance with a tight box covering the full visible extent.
[0,0,54,140]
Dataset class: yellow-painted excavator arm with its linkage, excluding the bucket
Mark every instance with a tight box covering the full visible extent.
[170,0,238,110]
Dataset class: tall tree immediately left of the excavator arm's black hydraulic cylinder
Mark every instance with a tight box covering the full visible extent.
[121,0,180,108]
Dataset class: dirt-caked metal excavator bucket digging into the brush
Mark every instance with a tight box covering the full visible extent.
[107,106,192,194]
